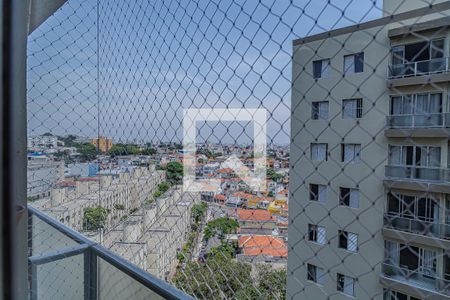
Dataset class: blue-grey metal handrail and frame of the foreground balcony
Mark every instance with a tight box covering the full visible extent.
[28,206,193,299]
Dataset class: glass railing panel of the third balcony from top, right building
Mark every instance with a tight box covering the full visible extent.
[385,166,450,182]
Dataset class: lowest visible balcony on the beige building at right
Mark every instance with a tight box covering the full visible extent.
[380,263,450,299]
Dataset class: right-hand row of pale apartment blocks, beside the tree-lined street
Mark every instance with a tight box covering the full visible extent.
[99,187,200,280]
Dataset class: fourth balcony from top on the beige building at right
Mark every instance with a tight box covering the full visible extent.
[383,214,450,247]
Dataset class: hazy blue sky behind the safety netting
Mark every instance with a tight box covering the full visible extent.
[28,0,382,144]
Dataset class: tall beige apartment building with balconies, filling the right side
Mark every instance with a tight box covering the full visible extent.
[287,0,450,300]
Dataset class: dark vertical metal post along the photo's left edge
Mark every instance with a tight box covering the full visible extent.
[0,0,29,300]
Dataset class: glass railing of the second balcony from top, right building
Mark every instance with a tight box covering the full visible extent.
[386,113,450,128]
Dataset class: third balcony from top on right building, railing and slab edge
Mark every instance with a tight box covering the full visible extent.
[384,165,450,193]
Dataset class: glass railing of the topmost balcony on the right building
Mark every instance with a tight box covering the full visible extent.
[388,57,449,78]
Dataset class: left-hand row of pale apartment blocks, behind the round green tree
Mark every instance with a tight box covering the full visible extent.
[32,166,165,231]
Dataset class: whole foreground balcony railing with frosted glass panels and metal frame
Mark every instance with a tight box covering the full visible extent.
[28,207,192,300]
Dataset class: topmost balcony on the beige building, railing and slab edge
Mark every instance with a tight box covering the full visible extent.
[388,57,450,87]
